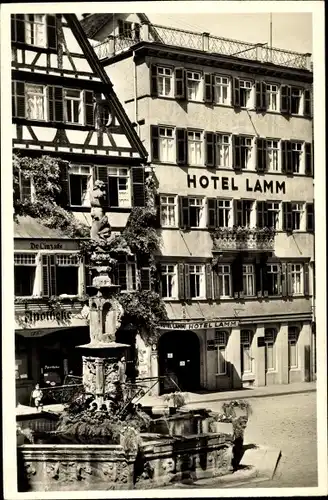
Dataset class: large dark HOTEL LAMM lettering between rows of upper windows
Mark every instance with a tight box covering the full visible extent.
[187,174,286,194]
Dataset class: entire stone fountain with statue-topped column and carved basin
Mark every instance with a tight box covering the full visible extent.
[14,181,251,491]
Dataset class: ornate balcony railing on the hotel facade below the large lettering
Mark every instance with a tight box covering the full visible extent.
[212,227,275,252]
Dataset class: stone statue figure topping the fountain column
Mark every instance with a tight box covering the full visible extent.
[90,181,112,243]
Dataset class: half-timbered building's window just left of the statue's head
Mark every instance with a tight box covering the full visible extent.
[69,165,92,207]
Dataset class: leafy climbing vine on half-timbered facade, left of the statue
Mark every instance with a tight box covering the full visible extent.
[13,154,90,238]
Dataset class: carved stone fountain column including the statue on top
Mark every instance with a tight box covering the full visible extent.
[78,181,130,413]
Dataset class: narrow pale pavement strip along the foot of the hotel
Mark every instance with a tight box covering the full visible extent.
[139,382,316,407]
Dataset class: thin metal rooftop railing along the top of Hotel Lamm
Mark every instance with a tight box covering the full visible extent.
[94,24,312,71]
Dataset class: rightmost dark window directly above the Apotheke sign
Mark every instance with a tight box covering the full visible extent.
[56,254,80,295]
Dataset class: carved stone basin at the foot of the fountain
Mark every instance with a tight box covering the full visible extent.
[18,411,233,491]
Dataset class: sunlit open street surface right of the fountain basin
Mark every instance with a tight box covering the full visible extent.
[195,392,317,488]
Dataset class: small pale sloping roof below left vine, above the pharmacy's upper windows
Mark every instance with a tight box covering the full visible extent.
[14,215,72,240]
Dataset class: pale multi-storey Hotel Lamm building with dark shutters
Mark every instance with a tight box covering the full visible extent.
[81,13,315,391]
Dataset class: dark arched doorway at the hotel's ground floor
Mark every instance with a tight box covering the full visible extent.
[158,330,200,394]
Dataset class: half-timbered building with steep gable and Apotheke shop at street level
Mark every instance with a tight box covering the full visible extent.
[11,14,147,403]
